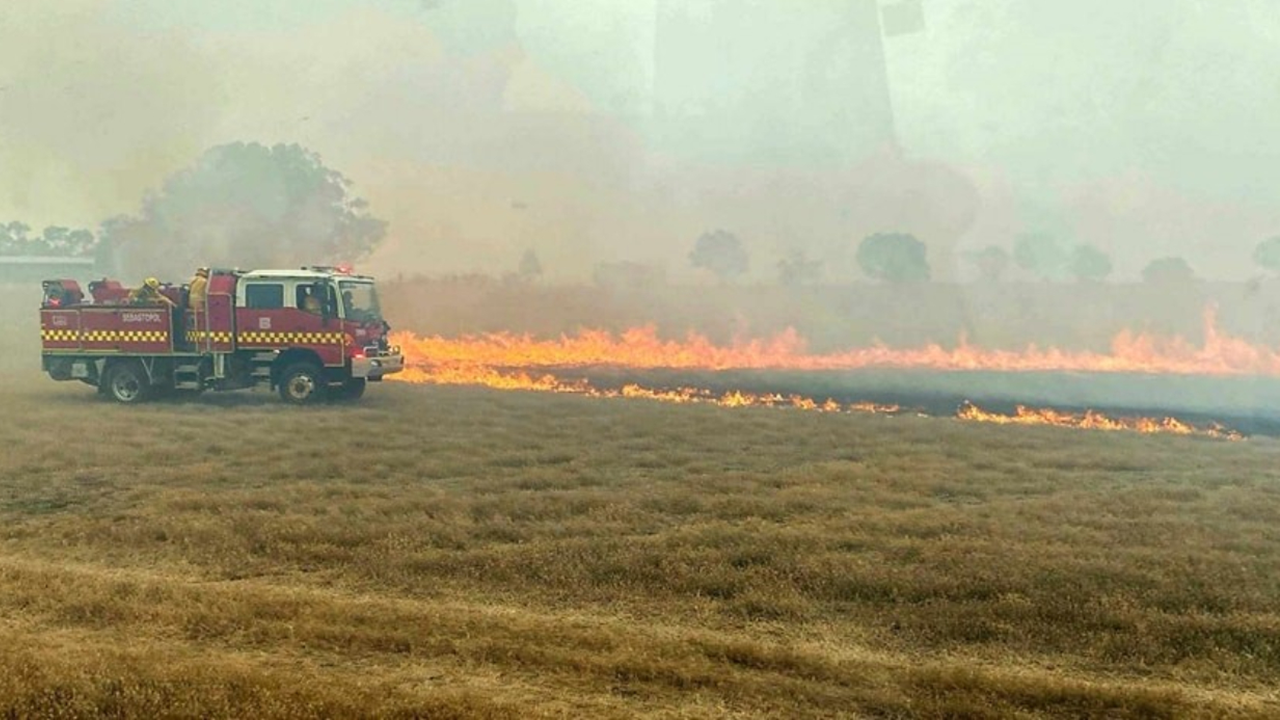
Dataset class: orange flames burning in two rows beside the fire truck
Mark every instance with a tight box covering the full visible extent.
[390,310,1249,439]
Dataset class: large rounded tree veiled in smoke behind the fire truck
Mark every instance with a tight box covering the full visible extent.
[102,142,387,275]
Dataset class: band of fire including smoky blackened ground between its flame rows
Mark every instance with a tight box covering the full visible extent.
[381,309,1280,439]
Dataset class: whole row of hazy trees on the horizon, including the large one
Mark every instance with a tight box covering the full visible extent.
[10,142,1280,286]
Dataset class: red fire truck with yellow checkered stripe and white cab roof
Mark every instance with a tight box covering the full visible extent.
[40,266,404,405]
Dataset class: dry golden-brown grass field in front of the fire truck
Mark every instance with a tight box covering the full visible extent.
[0,371,1280,719]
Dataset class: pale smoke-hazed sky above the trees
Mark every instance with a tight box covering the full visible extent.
[0,0,1280,277]
